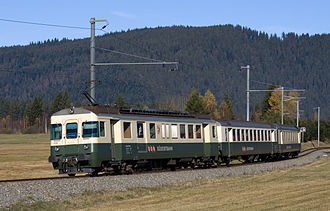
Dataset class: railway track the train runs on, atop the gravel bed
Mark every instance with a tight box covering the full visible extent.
[0,147,330,184]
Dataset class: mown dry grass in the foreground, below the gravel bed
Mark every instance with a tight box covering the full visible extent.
[12,154,330,210]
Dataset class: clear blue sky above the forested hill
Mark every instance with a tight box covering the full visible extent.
[0,0,330,47]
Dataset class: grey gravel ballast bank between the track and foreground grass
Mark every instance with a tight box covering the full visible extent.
[0,150,330,208]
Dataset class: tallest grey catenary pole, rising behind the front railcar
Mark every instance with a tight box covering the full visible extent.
[89,18,109,103]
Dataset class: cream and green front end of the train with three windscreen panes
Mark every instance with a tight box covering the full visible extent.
[48,108,107,176]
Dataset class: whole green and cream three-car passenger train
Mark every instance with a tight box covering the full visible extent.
[48,105,302,176]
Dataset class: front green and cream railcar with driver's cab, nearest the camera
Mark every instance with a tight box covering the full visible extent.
[49,107,218,175]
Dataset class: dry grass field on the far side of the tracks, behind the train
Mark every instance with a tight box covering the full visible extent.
[0,134,325,180]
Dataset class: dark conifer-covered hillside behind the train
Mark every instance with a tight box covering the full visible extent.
[0,25,330,119]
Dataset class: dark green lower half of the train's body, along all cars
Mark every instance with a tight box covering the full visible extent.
[49,142,300,174]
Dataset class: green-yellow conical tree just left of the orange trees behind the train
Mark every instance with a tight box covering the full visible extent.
[185,88,206,114]
